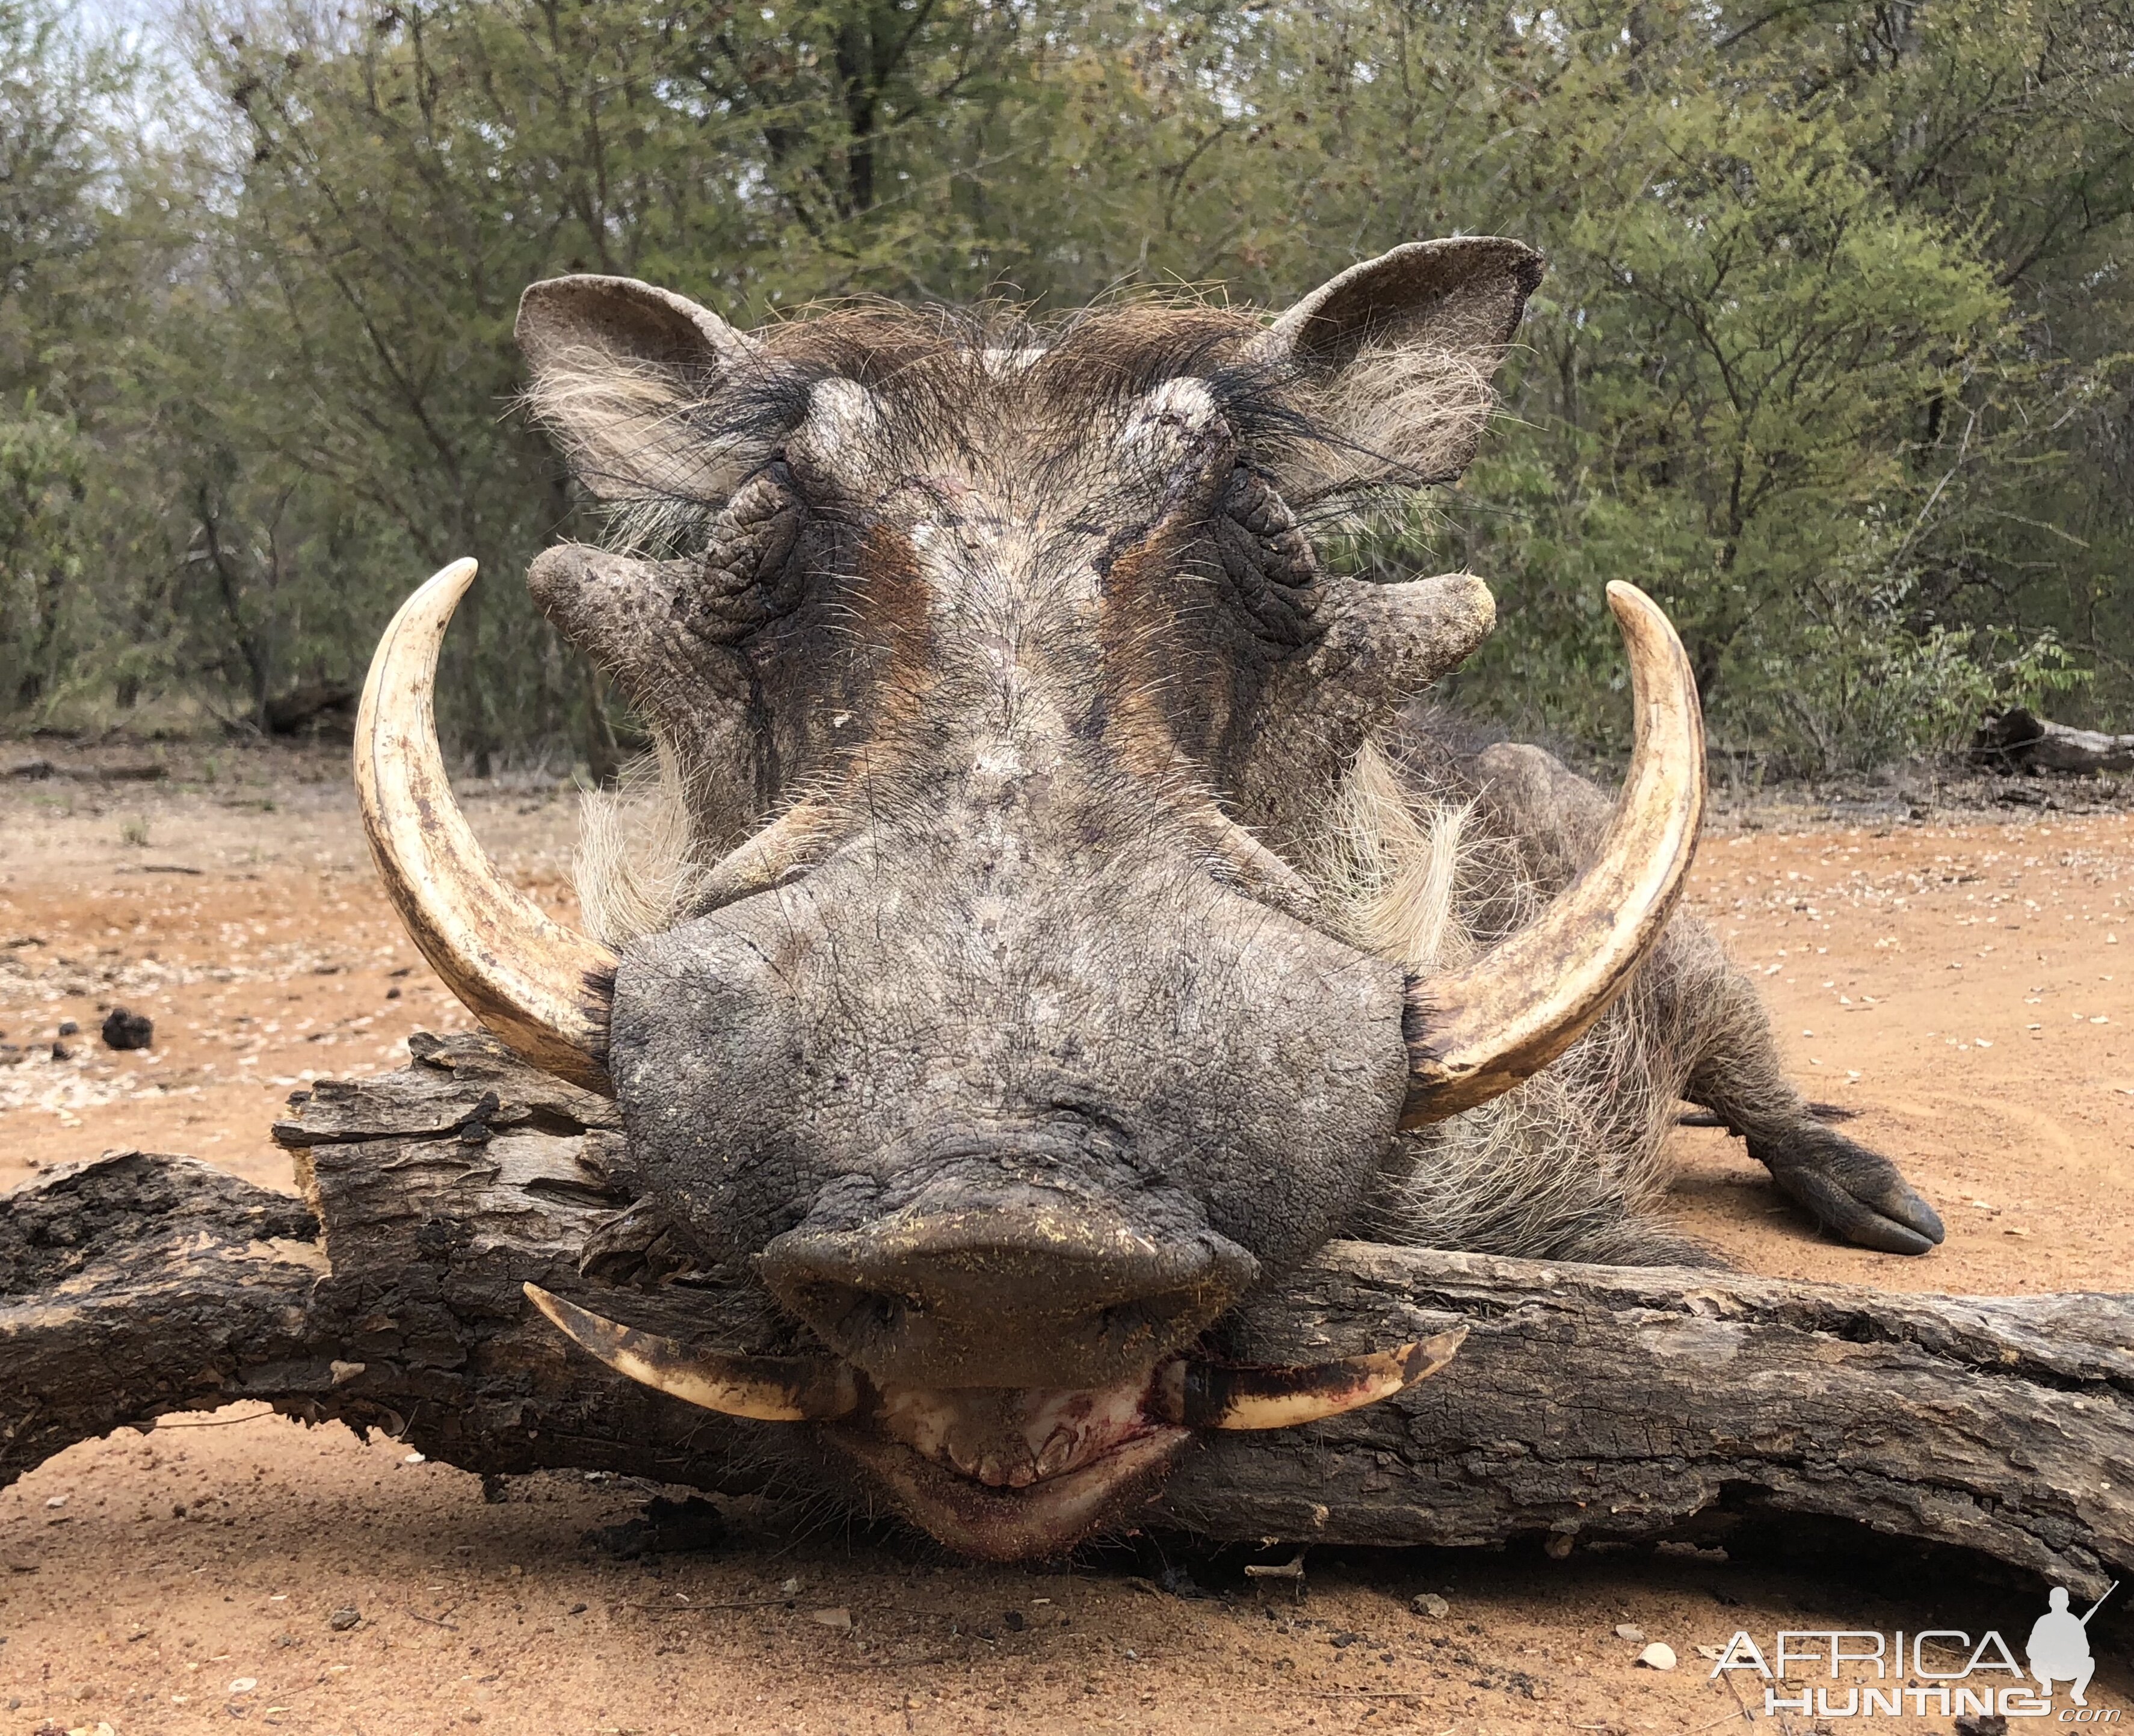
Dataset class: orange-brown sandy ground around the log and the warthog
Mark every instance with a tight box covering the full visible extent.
[0,748,2134,1736]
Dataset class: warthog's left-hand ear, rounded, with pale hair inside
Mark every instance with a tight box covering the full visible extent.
[516,277,764,508]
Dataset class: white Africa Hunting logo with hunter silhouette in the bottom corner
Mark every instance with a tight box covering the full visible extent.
[1712,1580,2119,1723]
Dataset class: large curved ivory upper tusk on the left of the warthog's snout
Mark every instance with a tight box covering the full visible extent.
[356,561,615,1096]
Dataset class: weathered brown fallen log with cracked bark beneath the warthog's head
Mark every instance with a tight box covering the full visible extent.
[0,1036,2134,1598]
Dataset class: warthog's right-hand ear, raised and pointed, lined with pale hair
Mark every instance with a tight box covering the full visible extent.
[1255,237,1541,501]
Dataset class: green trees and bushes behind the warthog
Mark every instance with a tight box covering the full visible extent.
[0,0,2134,772]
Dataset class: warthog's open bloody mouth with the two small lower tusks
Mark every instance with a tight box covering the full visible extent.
[525,1284,1466,1561]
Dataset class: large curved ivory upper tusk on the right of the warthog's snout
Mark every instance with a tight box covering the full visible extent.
[1400,582,1705,1128]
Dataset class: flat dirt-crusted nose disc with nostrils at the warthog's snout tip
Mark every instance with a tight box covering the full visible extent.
[760,1196,1259,1387]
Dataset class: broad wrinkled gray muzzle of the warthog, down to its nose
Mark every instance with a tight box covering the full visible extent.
[615,798,1406,1387]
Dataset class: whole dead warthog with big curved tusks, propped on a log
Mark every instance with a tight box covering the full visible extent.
[359,239,1942,1557]
